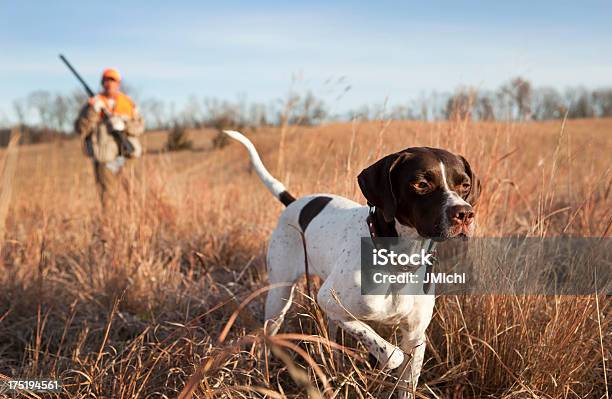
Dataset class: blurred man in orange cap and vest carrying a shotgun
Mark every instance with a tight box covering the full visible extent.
[75,69,144,208]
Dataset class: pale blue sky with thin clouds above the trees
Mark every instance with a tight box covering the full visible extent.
[0,0,612,120]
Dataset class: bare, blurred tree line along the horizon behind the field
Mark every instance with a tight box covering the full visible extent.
[0,77,612,145]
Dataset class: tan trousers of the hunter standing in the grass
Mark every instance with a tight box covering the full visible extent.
[93,160,134,209]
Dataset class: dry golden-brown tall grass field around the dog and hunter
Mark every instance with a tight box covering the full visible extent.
[0,119,612,398]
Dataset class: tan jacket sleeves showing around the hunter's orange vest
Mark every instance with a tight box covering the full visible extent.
[74,94,144,163]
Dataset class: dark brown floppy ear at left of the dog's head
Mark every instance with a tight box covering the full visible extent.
[357,153,402,223]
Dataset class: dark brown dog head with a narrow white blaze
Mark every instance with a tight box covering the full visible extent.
[358,147,480,240]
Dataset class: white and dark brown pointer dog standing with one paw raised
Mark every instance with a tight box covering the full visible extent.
[225,131,480,398]
